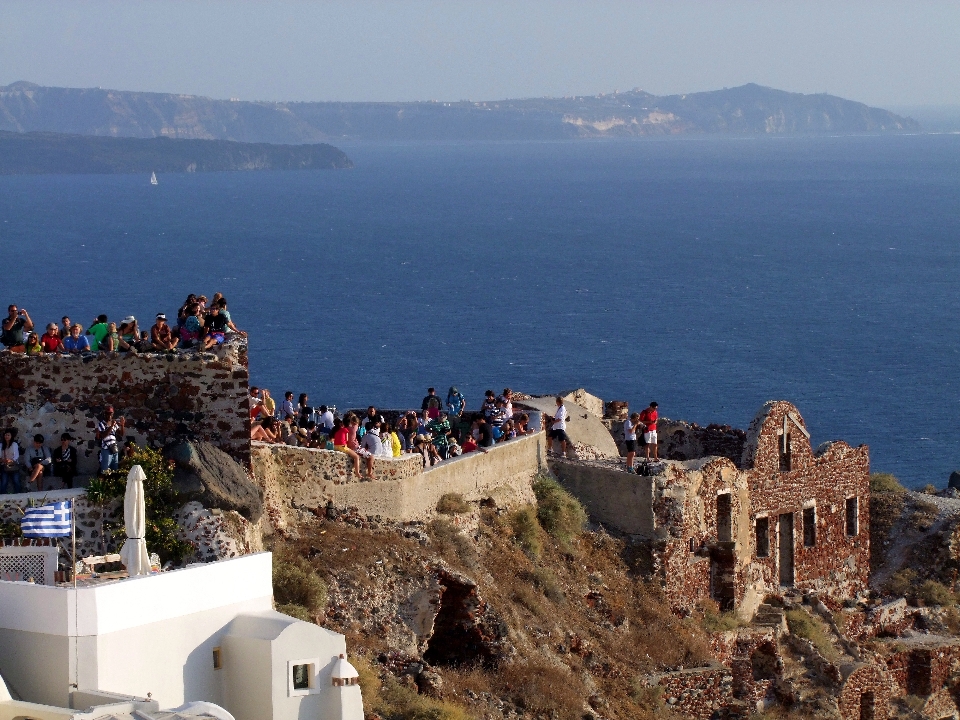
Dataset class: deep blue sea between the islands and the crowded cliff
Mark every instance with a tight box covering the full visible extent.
[0,136,960,486]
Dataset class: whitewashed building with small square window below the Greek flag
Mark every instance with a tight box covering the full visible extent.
[0,553,363,720]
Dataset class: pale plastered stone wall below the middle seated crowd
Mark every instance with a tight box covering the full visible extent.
[252,433,545,530]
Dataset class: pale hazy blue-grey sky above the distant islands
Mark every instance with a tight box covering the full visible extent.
[0,0,960,107]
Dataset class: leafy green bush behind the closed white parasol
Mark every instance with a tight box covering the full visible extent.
[86,448,194,562]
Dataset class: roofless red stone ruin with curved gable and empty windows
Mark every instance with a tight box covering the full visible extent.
[551,401,870,617]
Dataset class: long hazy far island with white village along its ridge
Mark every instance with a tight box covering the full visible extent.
[0,82,920,144]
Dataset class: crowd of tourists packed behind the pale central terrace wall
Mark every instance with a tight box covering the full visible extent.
[250,387,544,478]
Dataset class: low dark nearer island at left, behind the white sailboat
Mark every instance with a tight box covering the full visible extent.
[0,132,353,175]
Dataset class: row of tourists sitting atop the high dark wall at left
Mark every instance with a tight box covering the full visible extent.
[0,293,246,355]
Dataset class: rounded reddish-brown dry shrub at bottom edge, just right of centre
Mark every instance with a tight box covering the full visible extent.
[497,662,587,720]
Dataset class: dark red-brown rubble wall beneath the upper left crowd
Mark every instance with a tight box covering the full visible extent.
[0,345,250,475]
